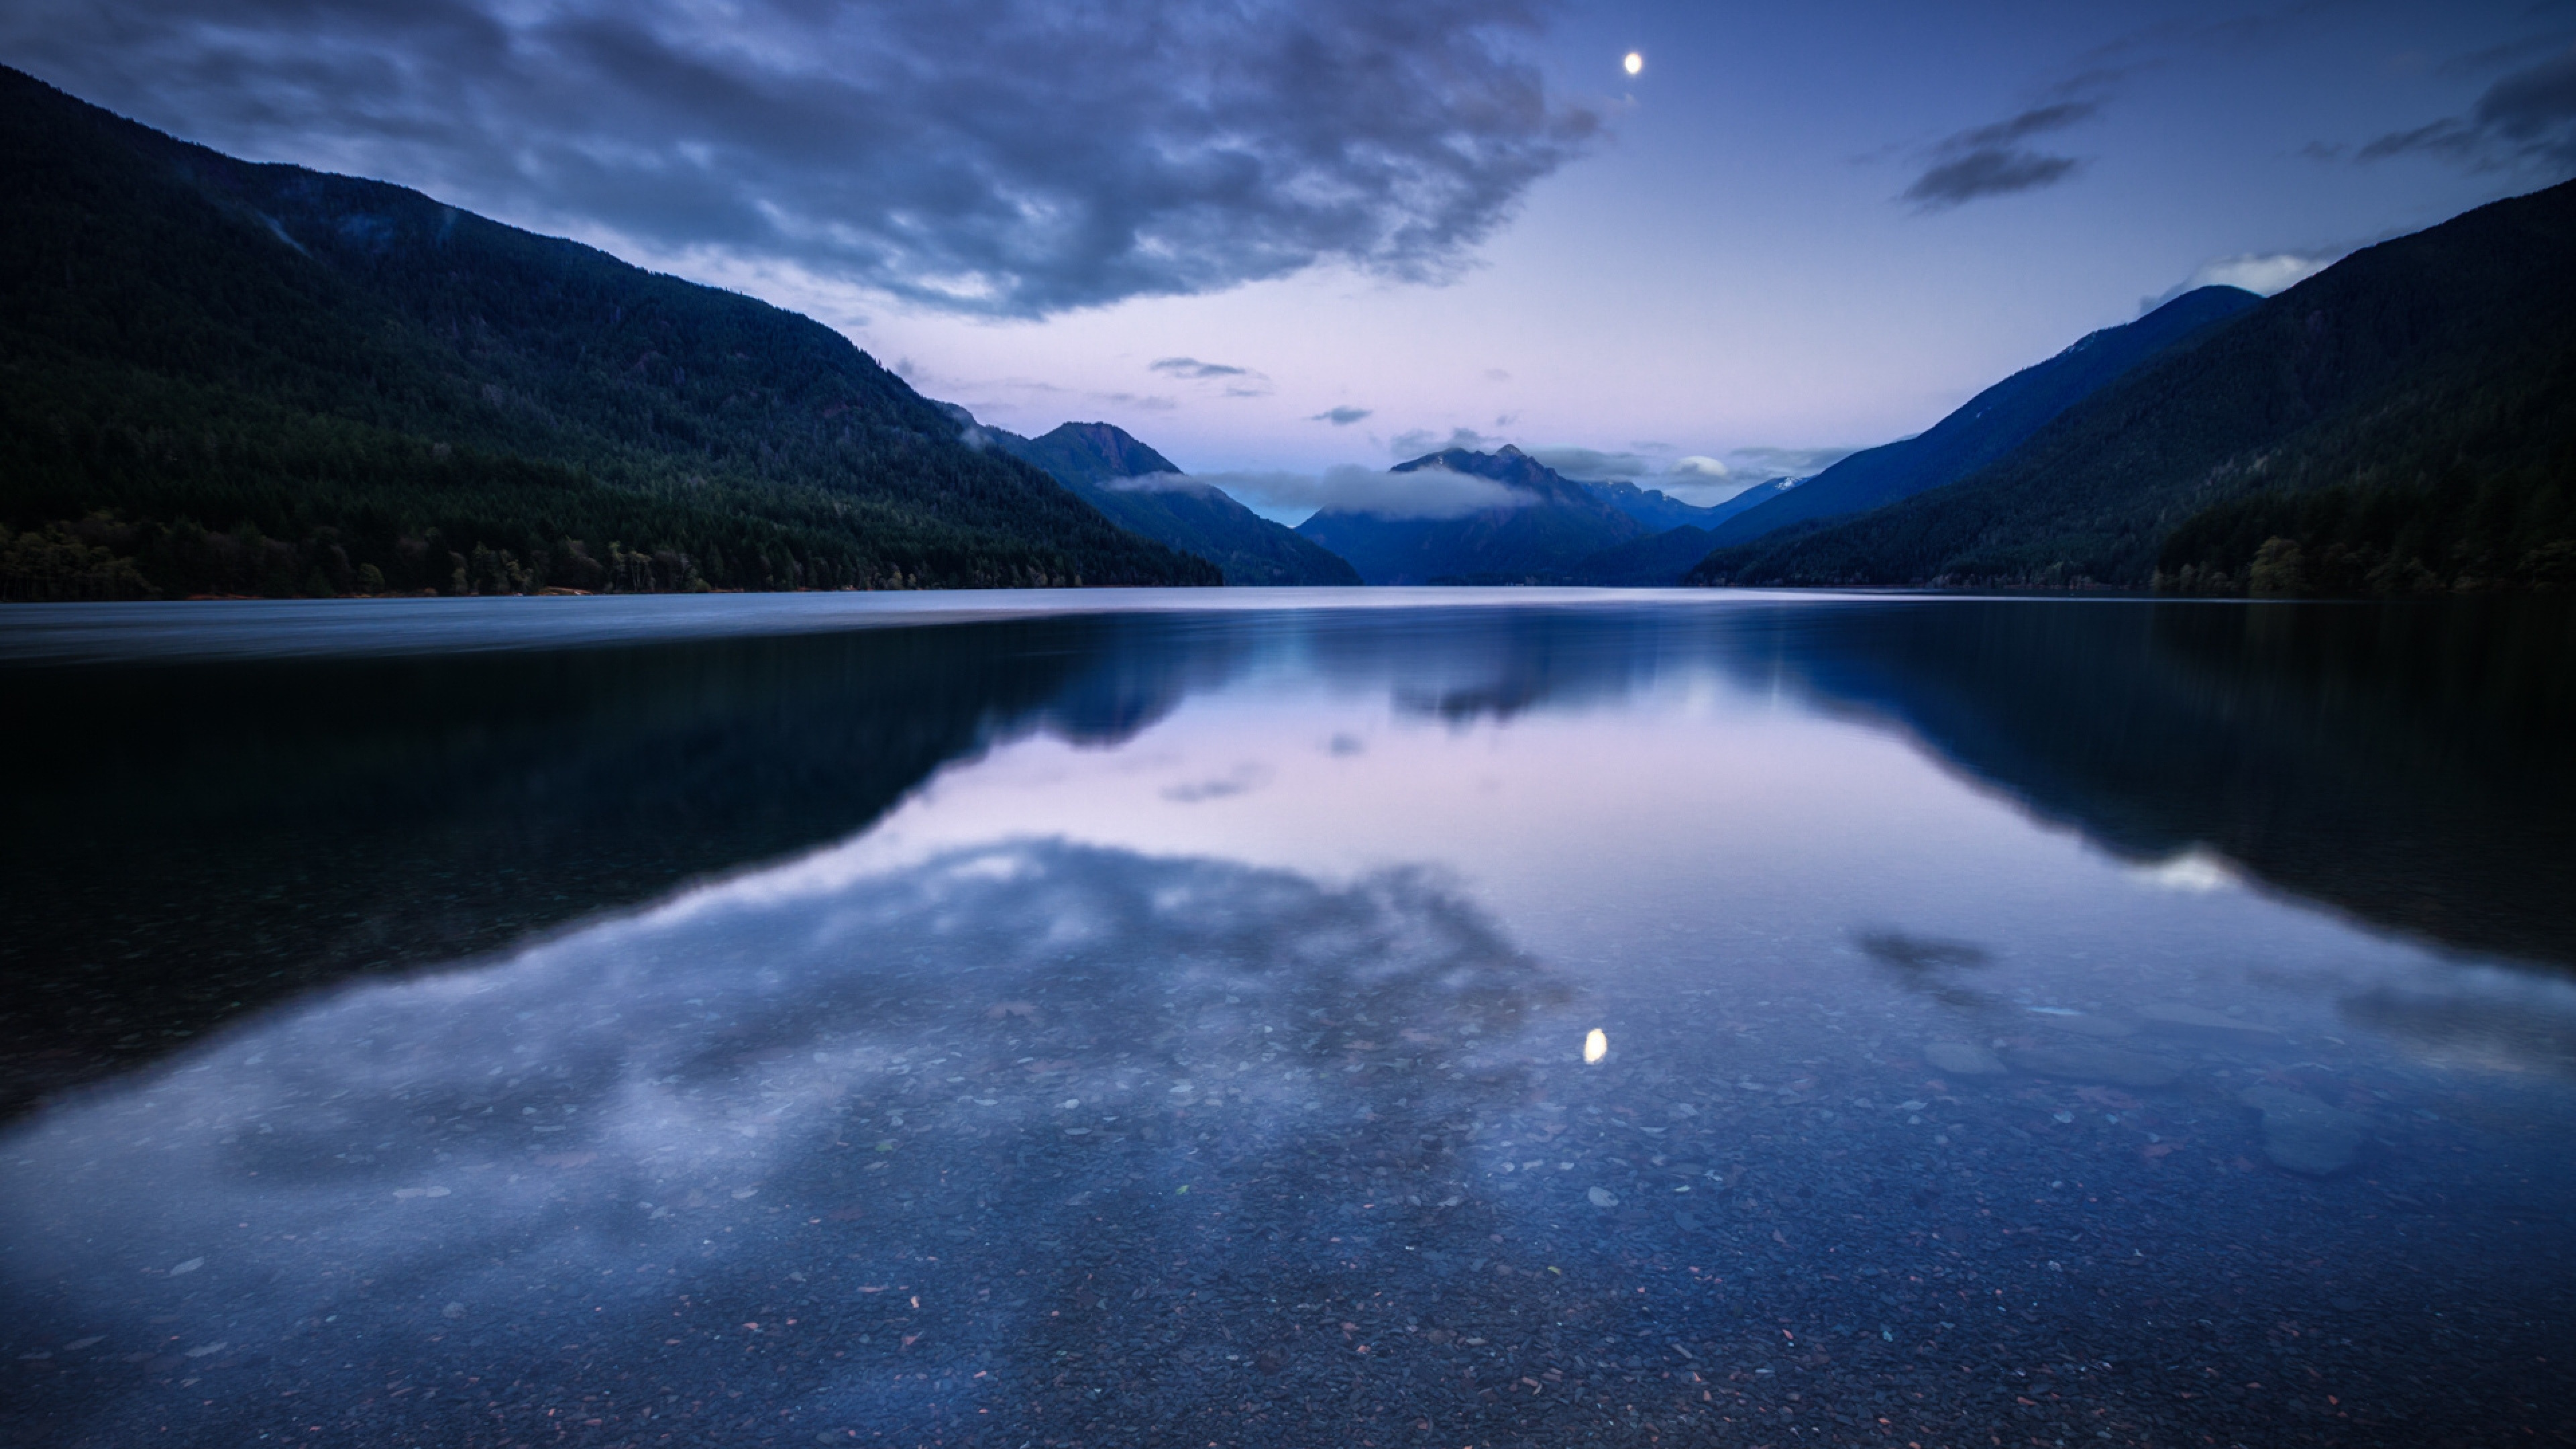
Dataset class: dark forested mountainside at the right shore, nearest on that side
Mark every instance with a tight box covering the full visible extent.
[1693,183,2576,593]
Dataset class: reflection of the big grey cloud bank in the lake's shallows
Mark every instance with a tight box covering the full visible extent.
[0,841,1569,1439]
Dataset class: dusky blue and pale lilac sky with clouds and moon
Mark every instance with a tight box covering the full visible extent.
[0,0,2576,521]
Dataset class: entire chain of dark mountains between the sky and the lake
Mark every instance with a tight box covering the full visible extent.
[0,70,2576,601]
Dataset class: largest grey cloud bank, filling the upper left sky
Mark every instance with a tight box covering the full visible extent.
[0,0,1600,317]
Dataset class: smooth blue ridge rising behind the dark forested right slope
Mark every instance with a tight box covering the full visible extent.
[1713,286,2262,549]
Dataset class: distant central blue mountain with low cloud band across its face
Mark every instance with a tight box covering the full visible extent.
[1296,446,1646,583]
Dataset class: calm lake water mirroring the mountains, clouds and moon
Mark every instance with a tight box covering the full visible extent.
[0,590,2576,1449]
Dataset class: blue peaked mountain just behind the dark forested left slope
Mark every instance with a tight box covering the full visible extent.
[958,410,1360,585]
